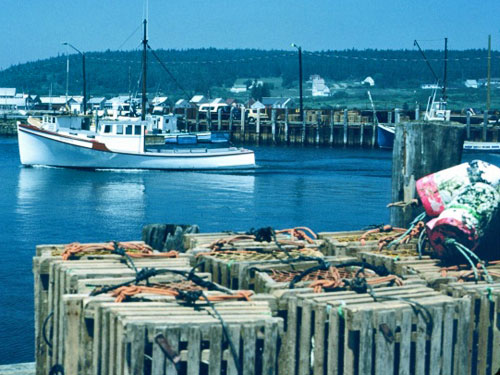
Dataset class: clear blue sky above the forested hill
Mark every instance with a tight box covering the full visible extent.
[0,0,500,69]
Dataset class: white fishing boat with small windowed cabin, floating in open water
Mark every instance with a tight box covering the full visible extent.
[17,116,255,170]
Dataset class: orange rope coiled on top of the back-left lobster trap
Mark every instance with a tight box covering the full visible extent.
[62,242,179,260]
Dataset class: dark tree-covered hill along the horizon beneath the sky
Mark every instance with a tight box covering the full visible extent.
[0,48,500,97]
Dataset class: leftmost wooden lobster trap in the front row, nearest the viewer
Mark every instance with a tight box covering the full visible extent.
[64,298,283,374]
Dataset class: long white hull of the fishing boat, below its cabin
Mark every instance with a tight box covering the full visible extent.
[18,125,255,170]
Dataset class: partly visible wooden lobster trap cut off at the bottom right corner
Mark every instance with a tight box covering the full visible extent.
[441,279,500,375]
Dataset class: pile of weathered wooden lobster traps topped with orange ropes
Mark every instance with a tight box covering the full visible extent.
[33,227,500,375]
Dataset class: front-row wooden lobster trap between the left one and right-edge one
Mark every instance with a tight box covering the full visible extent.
[280,285,470,375]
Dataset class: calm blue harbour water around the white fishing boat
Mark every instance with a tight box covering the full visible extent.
[0,137,500,364]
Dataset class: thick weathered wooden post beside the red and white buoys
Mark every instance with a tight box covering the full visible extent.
[391,121,465,228]
